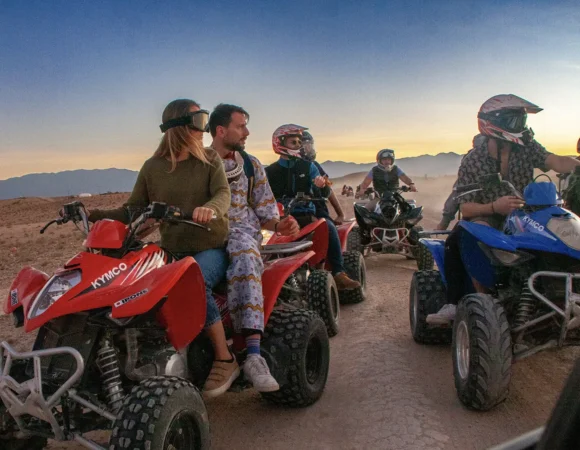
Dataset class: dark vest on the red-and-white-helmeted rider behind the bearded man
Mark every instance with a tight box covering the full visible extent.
[266,159,313,199]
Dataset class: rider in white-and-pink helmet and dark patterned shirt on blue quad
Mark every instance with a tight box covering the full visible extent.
[427,94,580,325]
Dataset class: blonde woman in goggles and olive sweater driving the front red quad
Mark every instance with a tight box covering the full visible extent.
[89,99,240,397]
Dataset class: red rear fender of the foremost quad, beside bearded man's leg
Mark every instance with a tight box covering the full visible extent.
[262,250,315,323]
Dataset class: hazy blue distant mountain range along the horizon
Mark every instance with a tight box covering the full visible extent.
[0,153,462,200]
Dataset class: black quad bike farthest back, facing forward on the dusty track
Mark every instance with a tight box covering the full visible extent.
[347,186,434,270]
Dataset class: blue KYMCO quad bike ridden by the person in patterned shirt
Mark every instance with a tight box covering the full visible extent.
[409,174,580,411]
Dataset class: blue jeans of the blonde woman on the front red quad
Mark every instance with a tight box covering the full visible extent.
[175,248,230,328]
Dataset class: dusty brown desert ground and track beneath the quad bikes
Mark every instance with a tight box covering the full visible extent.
[0,175,579,450]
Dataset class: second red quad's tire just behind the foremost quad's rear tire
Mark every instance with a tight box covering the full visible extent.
[307,270,340,337]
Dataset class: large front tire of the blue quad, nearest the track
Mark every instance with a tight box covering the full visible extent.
[453,294,512,411]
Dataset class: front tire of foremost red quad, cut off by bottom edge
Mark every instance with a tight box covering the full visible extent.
[109,376,210,450]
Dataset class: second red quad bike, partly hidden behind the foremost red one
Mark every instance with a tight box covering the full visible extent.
[264,193,366,336]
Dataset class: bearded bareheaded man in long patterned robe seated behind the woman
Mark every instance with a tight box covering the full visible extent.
[209,104,299,392]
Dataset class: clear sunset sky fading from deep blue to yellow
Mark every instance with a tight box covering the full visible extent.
[0,0,580,179]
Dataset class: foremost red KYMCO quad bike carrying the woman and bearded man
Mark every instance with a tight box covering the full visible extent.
[0,202,329,450]
